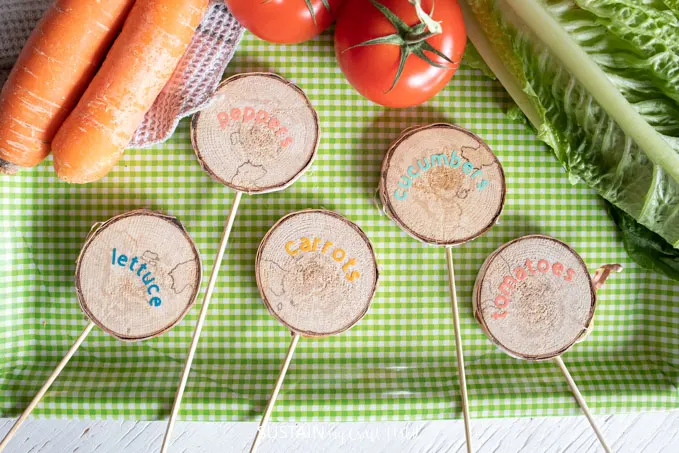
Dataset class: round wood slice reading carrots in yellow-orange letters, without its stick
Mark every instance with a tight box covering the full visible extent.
[255,209,379,337]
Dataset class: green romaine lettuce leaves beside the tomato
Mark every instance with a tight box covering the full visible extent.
[461,0,679,278]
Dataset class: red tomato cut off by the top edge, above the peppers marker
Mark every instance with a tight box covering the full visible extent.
[224,0,344,44]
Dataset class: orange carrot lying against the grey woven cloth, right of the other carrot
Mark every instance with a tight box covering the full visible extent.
[52,0,208,183]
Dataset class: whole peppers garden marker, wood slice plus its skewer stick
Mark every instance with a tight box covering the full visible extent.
[161,73,320,453]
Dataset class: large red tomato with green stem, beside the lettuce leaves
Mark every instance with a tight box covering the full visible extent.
[335,0,467,107]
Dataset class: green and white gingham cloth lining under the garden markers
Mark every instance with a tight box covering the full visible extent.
[0,33,679,421]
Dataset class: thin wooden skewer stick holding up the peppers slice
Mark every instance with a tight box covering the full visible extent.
[160,191,243,453]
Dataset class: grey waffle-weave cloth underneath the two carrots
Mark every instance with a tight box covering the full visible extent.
[0,0,243,148]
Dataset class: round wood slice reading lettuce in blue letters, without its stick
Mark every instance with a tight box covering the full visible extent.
[75,209,202,341]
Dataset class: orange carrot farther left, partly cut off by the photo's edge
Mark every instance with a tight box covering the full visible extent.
[0,0,134,167]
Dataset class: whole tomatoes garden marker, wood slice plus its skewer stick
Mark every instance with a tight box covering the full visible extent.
[473,235,622,452]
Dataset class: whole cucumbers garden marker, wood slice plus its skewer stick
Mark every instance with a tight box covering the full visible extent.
[379,123,506,452]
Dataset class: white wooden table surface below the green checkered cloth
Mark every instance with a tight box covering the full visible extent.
[0,411,679,453]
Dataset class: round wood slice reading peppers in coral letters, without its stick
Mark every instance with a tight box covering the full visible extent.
[191,72,320,194]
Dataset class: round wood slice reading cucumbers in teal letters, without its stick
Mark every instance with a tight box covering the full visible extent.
[379,123,506,246]
